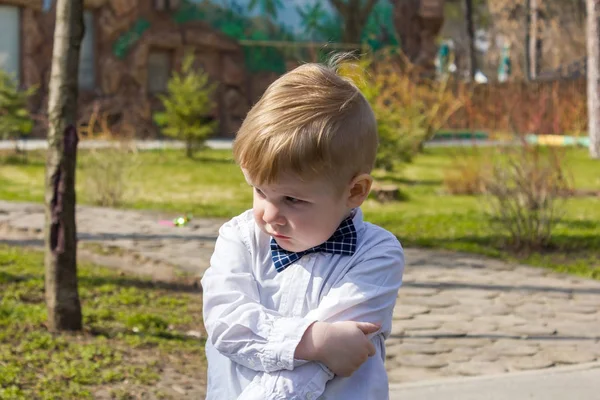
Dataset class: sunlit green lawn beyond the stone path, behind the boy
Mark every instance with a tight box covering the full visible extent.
[0,148,600,279]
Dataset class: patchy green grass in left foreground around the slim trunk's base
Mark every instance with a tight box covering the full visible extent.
[0,245,206,400]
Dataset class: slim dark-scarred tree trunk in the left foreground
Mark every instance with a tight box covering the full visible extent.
[44,0,83,331]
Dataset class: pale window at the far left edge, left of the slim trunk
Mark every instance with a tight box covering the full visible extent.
[0,5,21,82]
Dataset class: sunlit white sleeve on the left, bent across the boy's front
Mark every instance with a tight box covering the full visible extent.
[202,219,315,372]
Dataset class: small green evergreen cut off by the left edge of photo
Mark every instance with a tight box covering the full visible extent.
[0,69,36,140]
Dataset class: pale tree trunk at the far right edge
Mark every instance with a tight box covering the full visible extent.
[586,0,600,159]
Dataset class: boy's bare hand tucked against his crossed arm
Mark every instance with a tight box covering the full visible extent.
[296,321,380,377]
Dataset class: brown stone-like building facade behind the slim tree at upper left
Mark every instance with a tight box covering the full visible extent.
[0,0,251,137]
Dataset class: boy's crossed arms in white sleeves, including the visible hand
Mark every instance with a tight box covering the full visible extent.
[202,220,403,399]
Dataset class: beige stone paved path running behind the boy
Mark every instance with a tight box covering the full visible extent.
[0,201,600,382]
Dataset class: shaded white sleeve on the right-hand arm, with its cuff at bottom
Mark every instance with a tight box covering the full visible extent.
[238,244,404,400]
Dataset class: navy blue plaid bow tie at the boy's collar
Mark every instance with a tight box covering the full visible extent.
[271,216,356,272]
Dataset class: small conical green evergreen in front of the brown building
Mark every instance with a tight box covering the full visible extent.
[154,53,216,157]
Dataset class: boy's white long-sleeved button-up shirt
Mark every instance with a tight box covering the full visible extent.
[202,209,404,400]
